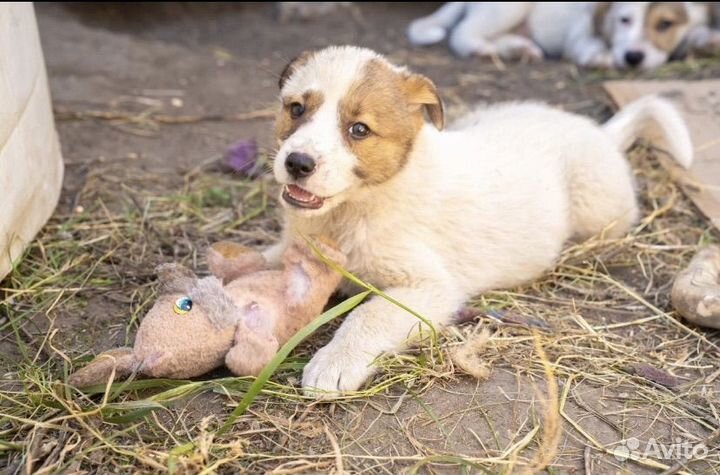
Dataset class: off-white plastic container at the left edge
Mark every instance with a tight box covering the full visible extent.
[0,3,63,279]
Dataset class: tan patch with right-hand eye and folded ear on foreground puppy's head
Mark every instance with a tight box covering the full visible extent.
[339,60,444,184]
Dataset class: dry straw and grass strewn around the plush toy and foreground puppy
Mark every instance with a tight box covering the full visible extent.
[0,121,720,474]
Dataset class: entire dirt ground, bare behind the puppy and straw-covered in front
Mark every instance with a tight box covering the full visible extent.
[0,3,720,474]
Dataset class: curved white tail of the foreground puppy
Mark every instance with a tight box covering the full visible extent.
[603,96,693,168]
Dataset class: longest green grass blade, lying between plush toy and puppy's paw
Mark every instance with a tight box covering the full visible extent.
[218,290,371,435]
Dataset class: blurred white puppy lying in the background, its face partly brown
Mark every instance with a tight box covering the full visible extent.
[408,2,720,69]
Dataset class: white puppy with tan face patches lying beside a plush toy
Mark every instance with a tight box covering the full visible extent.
[266,47,692,392]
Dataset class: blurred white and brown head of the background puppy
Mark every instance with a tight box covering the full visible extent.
[594,2,690,69]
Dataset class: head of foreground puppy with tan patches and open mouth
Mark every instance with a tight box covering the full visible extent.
[274,46,444,215]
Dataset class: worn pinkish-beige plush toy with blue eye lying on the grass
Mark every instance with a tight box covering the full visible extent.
[68,239,345,387]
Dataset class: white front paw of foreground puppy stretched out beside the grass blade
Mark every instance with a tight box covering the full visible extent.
[302,343,375,398]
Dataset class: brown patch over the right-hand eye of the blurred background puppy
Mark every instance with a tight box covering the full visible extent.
[645,2,689,53]
